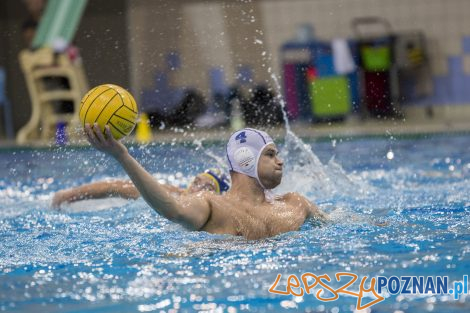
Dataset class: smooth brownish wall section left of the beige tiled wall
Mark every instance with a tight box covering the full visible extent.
[128,0,268,105]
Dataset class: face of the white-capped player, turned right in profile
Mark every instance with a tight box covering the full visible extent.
[258,144,284,189]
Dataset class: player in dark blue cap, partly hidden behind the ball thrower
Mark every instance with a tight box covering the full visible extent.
[52,168,230,208]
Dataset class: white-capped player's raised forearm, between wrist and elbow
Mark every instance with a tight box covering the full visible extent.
[115,152,180,221]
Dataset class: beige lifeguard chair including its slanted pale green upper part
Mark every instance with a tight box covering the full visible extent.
[16,0,88,144]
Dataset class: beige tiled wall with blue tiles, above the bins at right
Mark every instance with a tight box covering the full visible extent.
[260,0,470,105]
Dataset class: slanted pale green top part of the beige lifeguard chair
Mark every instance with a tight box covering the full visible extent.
[32,0,87,48]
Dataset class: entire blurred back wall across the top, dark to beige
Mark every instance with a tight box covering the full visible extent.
[0,0,470,135]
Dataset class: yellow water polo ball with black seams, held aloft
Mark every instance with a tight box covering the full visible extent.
[79,84,138,140]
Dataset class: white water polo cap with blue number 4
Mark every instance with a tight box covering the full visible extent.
[227,128,274,188]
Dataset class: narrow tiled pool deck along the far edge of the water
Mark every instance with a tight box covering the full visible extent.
[0,105,470,148]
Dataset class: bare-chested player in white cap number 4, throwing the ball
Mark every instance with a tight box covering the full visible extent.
[85,124,326,239]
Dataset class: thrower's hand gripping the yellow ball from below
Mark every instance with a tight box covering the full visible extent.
[85,123,127,158]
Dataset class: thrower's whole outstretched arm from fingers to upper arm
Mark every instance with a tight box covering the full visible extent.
[85,124,210,230]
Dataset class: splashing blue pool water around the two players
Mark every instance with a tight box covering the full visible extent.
[0,134,470,312]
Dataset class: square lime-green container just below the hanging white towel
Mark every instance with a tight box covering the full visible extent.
[309,76,351,119]
